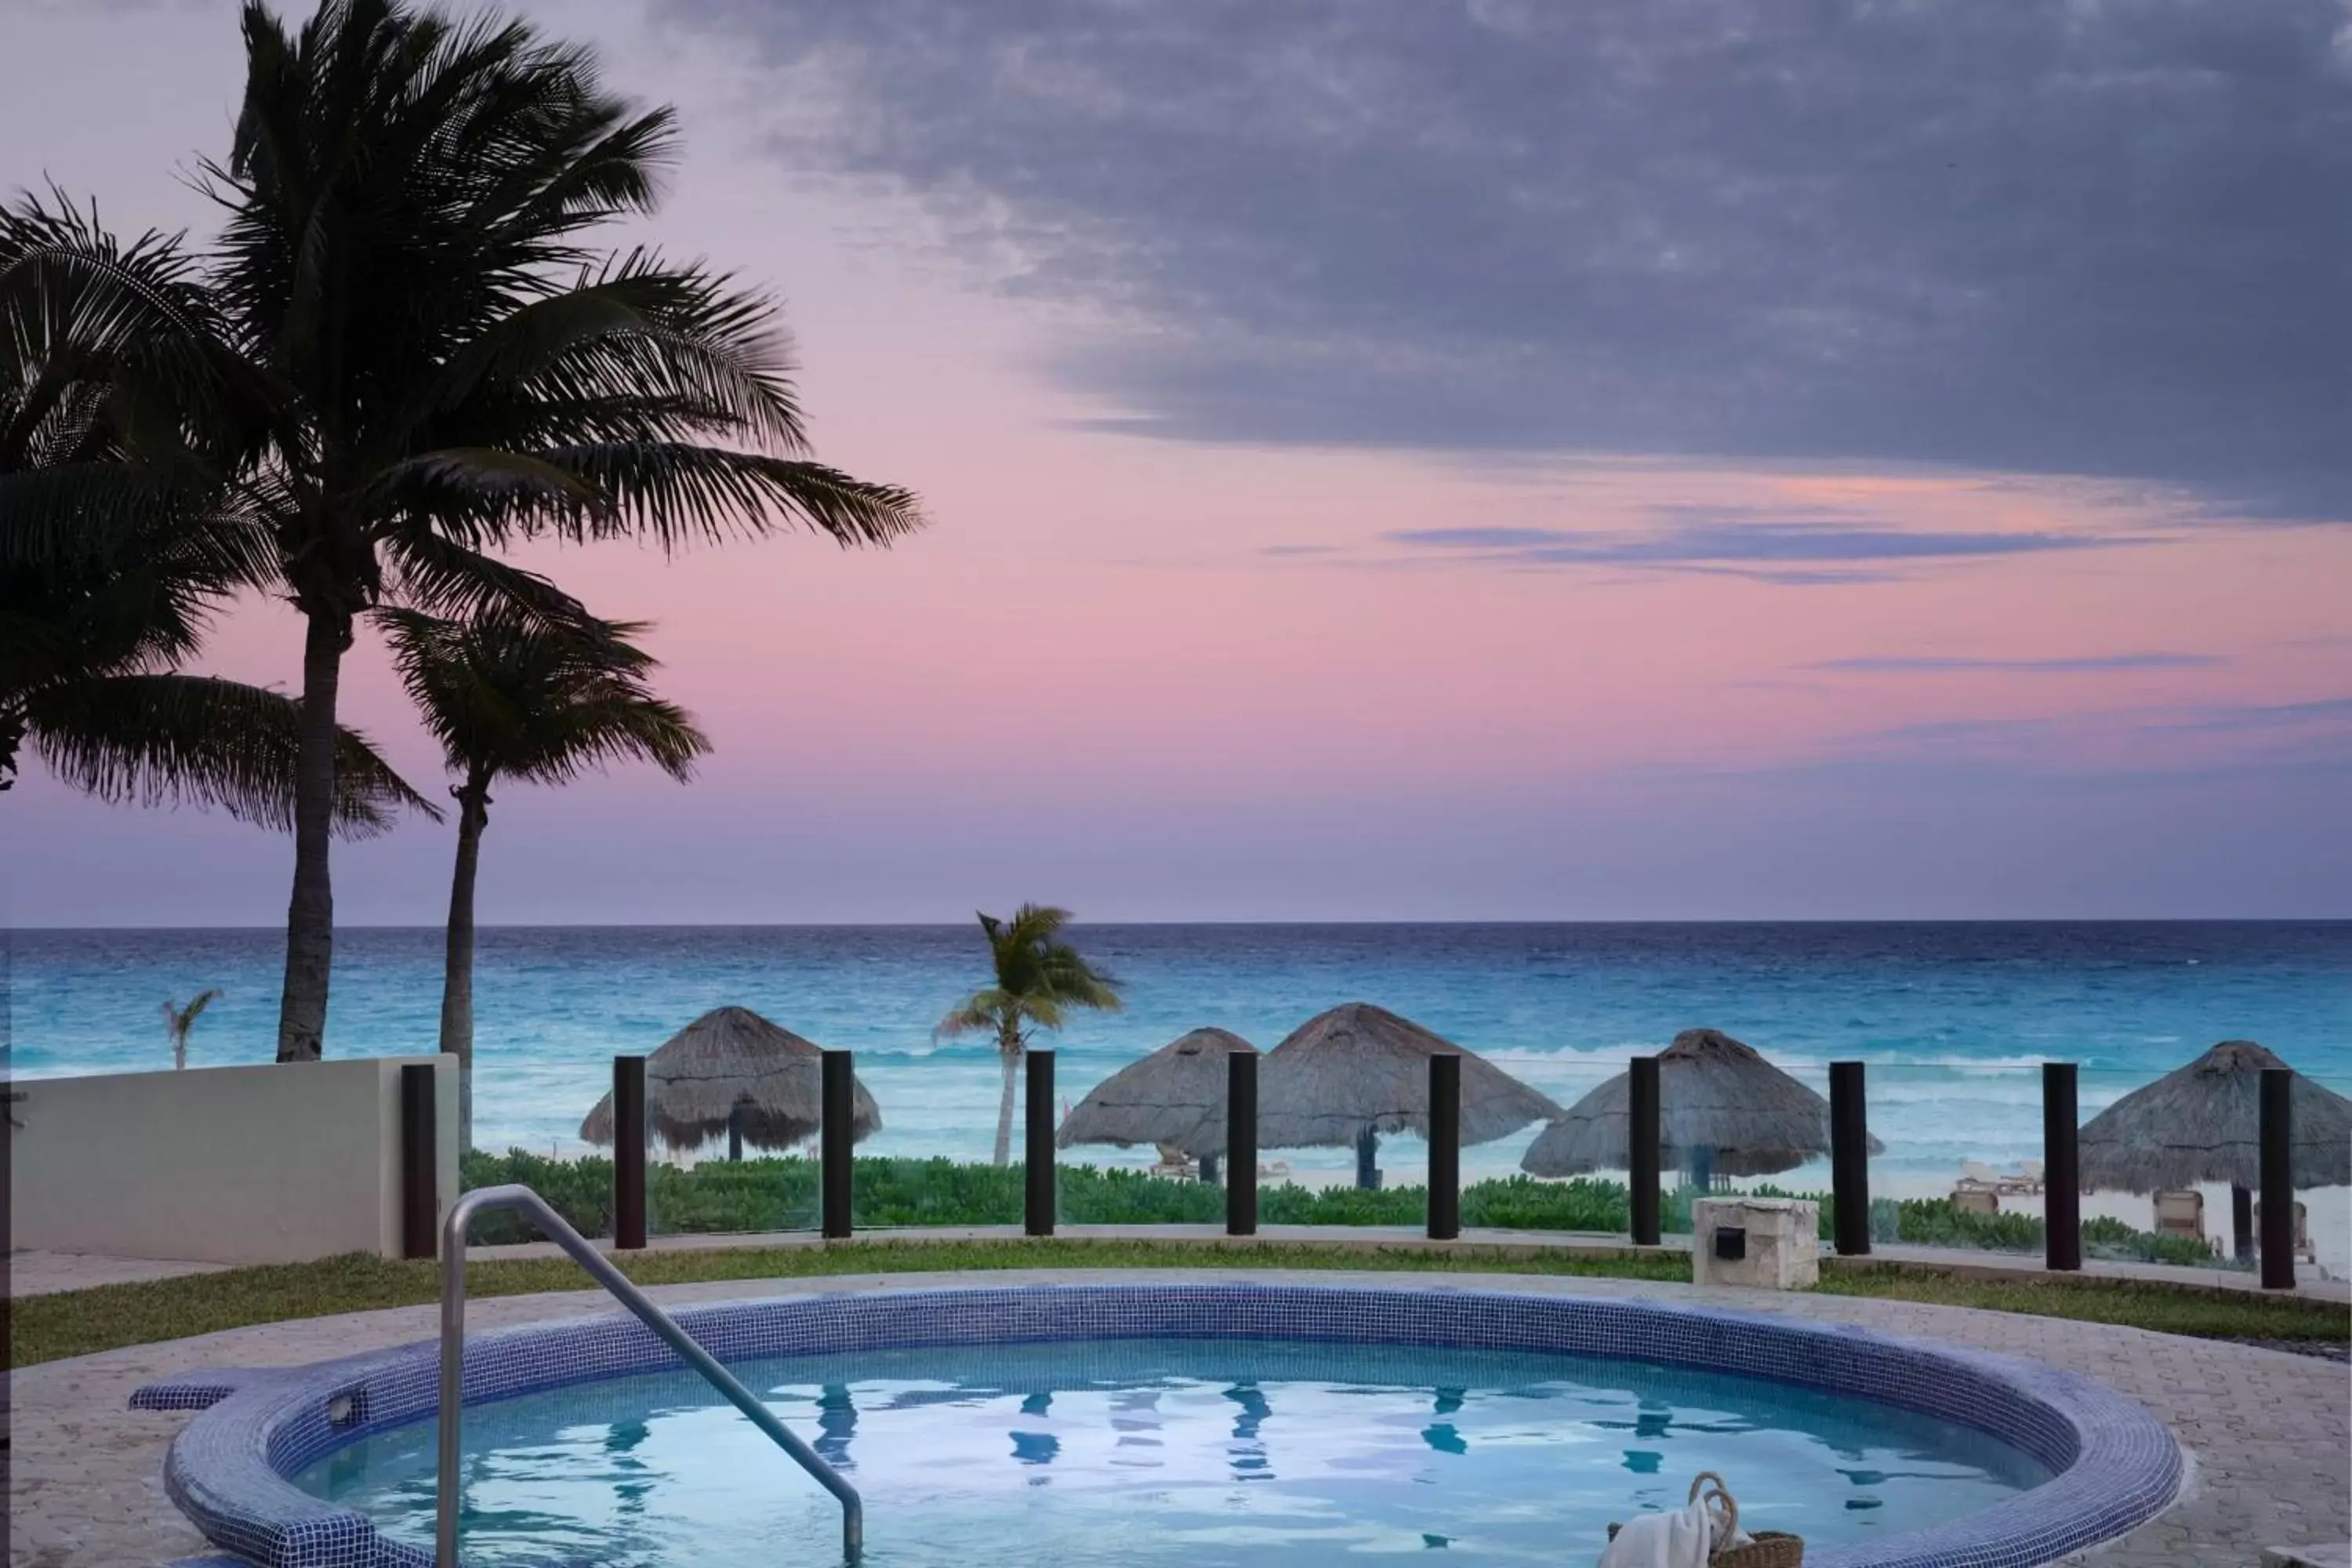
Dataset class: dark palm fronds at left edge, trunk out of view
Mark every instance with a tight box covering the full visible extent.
[0,198,433,834]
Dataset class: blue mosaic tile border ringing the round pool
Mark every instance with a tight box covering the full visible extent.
[132,1283,2183,1568]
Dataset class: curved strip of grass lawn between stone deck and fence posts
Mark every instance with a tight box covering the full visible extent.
[9,1241,2352,1366]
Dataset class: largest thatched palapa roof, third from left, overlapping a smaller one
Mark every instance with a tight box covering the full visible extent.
[1258,1001,1559,1149]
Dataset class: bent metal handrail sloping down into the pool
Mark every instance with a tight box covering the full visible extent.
[433,1185,866,1568]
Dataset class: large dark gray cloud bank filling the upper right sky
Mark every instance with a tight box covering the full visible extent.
[656,0,2352,520]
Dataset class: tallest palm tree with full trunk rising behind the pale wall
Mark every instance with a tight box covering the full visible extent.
[205,0,920,1060]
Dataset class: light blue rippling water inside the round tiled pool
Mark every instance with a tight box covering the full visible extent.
[299,1340,2049,1568]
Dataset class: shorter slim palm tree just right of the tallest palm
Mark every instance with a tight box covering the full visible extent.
[376,607,710,1149]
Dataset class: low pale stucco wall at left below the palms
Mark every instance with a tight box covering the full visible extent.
[9,1055,456,1262]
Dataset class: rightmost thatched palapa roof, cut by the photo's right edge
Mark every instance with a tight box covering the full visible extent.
[2077,1039,2352,1192]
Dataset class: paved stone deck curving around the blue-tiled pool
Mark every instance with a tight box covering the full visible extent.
[9,1255,2352,1568]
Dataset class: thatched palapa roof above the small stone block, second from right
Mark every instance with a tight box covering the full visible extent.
[1519,1029,1886,1175]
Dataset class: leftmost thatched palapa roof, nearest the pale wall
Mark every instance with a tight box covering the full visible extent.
[581,1006,882,1149]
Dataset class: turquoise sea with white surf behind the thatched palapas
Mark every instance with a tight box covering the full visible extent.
[5,921,2352,1178]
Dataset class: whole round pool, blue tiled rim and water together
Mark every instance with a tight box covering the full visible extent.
[141,1283,2180,1568]
